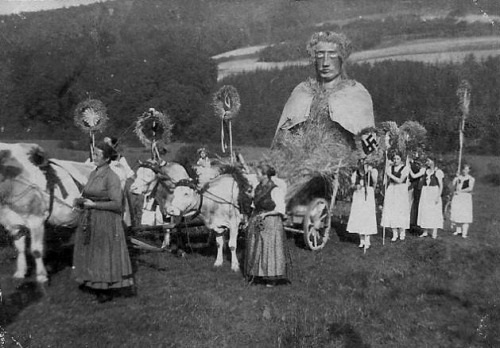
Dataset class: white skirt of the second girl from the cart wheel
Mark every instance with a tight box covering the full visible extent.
[380,183,410,229]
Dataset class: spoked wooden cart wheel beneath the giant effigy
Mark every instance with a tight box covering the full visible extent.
[303,198,332,250]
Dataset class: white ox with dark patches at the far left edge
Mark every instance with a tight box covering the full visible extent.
[0,143,95,282]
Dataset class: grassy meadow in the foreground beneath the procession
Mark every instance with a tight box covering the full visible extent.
[0,143,500,348]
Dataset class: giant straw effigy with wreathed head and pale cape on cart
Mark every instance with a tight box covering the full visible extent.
[269,31,375,204]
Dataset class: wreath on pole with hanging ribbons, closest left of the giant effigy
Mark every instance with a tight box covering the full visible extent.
[212,85,241,163]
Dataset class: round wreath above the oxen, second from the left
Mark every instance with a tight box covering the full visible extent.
[134,108,173,147]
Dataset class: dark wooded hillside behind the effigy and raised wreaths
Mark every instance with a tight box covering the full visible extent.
[0,0,500,155]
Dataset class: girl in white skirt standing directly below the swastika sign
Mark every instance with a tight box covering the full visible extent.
[347,162,378,250]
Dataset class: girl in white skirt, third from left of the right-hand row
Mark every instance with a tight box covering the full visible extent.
[410,158,444,239]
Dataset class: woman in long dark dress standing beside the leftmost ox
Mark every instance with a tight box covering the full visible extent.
[73,143,134,302]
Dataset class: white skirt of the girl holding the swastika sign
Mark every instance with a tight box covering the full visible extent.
[347,187,377,235]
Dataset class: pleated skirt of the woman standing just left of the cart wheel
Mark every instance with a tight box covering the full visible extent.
[245,215,291,280]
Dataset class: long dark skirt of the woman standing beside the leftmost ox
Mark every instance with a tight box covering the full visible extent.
[73,209,134,289]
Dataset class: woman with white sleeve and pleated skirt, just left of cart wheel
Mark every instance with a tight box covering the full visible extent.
[245,165,290,286]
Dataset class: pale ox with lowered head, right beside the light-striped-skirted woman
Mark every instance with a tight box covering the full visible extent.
[167,174,242,272]
